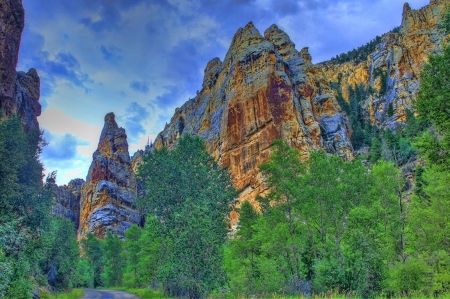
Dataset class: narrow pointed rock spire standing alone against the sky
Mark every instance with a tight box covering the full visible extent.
[78,113,140,238]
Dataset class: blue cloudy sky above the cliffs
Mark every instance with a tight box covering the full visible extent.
[17,0,429,185]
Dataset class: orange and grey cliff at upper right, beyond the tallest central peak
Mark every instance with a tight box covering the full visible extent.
[318,0,449,128]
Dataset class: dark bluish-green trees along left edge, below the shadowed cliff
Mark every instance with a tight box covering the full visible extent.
[0,117,51,298]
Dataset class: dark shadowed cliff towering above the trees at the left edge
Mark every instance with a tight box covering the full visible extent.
[0,0,41,131]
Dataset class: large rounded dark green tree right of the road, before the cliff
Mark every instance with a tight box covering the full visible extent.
[138,135,235,298]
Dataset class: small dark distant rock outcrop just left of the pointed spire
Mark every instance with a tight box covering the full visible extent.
[52,179,84,231]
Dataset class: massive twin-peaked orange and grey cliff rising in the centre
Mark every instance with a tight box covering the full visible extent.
[149,23,353,221]
